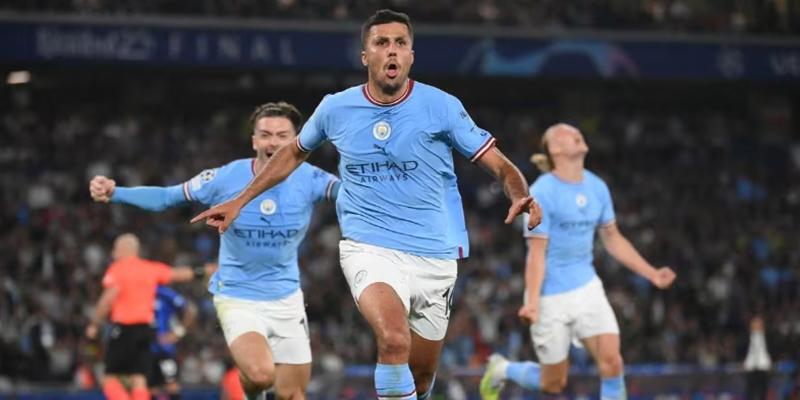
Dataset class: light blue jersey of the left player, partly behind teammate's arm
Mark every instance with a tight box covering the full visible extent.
[183,159,337,300]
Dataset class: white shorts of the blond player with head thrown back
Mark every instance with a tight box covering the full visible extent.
[530,277,619,364]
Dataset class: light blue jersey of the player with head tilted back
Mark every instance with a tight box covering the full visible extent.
[524,170,615,296]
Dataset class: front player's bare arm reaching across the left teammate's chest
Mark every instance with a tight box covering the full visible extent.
[191,143,309,234]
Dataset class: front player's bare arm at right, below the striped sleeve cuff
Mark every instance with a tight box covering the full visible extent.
[478,147,542,229]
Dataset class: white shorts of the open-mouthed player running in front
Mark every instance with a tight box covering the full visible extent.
[339,240,458,340]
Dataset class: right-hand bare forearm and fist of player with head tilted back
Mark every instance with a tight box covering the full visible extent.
[600,222,676,289]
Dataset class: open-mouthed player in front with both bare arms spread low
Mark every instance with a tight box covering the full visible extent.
[192,10,540,399]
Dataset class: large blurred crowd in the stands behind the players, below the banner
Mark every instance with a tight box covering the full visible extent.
[0,77,800,389]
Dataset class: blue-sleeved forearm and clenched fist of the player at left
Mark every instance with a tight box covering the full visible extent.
[89,175,189,211]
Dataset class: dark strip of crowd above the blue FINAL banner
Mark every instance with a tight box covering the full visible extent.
[0,0,800,34]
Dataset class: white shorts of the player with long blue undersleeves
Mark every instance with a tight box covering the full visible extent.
[214,290,311,364]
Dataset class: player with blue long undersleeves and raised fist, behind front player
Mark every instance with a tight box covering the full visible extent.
[89,102,339,399]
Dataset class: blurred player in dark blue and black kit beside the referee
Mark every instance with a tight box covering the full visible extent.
[147,286,197,400]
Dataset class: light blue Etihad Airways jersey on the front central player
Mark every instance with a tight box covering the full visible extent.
[297,80,495,259]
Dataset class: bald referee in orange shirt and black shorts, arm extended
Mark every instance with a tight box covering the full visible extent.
[86,233,215,400]
